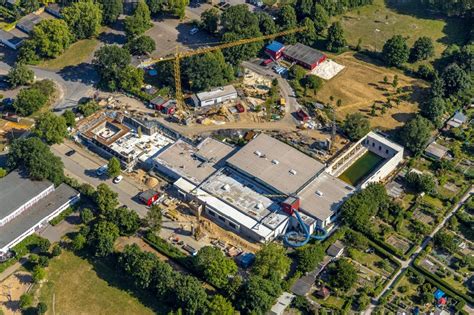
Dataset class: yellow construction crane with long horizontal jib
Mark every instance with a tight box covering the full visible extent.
[143,26,307,112]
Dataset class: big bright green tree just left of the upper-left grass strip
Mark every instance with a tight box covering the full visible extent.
[31,19,73,58]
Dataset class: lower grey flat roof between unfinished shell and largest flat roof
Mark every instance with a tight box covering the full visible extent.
[153,138,234,185]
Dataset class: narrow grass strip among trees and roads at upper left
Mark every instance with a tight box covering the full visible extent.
[38,38,99,70]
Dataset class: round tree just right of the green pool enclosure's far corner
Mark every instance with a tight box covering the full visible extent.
[400,115,433,154]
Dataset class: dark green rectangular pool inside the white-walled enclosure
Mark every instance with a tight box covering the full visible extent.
[339,151,385,186]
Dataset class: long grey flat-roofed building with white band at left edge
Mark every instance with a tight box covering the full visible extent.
[0,170,79,255]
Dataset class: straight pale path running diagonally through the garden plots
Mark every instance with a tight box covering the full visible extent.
[365,186,474,314]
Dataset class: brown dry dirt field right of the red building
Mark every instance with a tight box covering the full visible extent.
[317,52,426,129]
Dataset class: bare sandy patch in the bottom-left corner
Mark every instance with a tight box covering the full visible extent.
[0,272,32,315]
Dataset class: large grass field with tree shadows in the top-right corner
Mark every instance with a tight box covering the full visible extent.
[340,0,468,57]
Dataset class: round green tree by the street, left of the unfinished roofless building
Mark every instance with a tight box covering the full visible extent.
[34,112,67,144]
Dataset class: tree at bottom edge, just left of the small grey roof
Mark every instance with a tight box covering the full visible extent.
[236,276,281,314]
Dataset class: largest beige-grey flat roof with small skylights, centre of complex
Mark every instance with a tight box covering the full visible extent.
[227,133,325,195]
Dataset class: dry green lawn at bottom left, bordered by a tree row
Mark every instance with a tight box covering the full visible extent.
[37,251,158,314]
